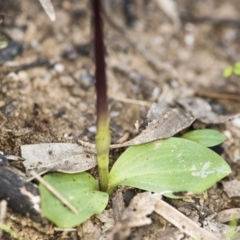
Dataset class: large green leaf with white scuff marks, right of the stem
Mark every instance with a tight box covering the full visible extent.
[109,138,231,196]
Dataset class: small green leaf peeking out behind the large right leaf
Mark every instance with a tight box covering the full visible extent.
[182,129,226,147]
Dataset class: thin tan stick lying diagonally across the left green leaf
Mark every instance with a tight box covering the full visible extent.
[31,171,78,215]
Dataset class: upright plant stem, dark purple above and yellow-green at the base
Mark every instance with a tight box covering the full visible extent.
[92,0,110,191]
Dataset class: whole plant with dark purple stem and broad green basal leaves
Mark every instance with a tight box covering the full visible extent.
[40,0,231,228]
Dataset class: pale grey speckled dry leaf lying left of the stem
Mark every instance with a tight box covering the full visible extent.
[21,143,97,175]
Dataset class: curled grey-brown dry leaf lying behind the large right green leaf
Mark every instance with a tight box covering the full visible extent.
[78,97,240,148]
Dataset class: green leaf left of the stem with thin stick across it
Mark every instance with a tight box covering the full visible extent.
[39,173,108,228]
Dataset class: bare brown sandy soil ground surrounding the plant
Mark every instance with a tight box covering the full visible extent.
[0,0,240,240]
